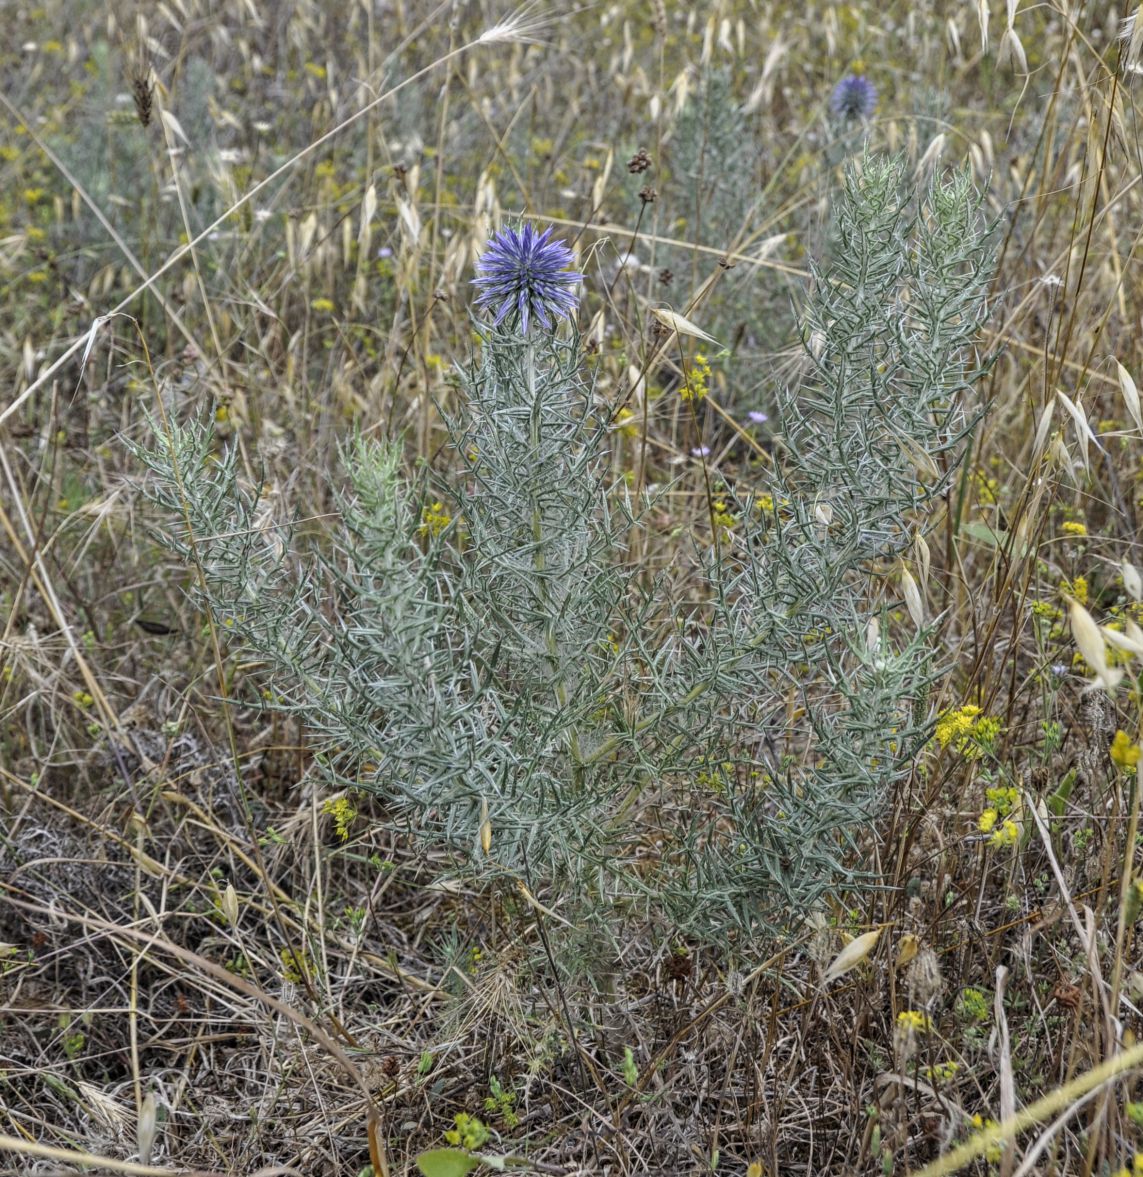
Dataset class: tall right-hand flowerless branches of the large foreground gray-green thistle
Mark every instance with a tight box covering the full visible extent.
[663,158,991,927]
